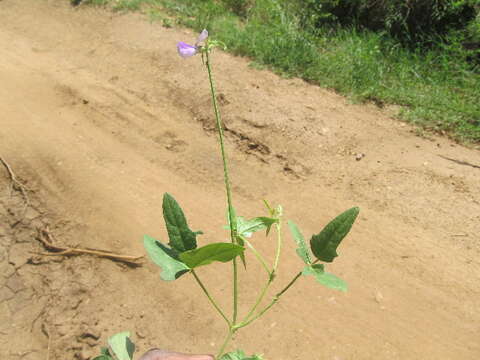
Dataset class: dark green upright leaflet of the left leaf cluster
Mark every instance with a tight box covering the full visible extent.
[162,193,202,252]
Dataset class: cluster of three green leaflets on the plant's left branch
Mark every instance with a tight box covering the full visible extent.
[143,193,245,281]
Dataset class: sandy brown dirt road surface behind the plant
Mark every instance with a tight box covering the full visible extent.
[0,0,480,360]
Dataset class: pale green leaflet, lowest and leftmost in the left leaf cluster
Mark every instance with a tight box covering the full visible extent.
[143,235,190,281]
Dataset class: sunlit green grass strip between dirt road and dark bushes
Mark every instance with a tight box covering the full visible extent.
[83,0,480,144]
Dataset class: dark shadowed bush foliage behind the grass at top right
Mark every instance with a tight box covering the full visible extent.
[294,0,480,44]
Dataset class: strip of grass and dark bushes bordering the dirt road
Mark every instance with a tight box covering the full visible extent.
[83,0,480,145]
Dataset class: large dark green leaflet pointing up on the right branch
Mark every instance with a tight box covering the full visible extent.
[310,207,360,262]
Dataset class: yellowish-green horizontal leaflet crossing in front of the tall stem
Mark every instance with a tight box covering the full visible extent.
[179,243,245,269]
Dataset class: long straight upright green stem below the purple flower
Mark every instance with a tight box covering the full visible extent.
[205,44,238,324]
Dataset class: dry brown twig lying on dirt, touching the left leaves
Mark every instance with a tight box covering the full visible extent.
[38,227,143,266]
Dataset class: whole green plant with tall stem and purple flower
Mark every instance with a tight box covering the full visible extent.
[96,30,359,360]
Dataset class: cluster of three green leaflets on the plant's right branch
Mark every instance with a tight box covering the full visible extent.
[288,207,360,291]
